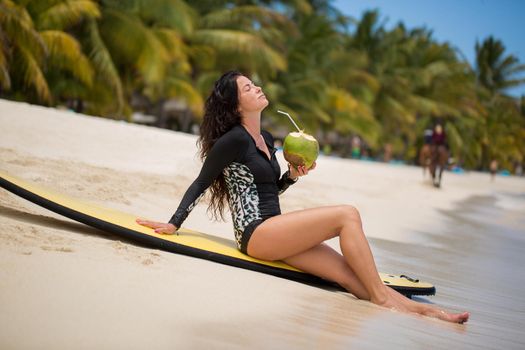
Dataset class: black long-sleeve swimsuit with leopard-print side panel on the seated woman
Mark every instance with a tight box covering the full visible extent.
[169,125,294,253]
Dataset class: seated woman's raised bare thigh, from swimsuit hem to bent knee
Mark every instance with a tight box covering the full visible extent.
[248,205,359,260]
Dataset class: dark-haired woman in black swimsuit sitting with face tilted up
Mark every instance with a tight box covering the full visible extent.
[137,71,469,323]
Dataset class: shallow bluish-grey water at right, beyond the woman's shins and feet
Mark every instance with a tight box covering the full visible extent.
[375,193,525,349]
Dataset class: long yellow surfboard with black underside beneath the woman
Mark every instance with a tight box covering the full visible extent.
[0,172,436,296]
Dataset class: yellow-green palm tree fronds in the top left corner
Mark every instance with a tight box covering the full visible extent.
[0,0,100,104]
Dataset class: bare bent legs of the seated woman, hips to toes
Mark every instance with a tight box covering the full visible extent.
[248,206,469,323]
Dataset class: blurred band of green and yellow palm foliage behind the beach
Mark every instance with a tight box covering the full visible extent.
[0,0,525,169]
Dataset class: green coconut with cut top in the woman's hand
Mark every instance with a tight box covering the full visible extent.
[283,131,319,169]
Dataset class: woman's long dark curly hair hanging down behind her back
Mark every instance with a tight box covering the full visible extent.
[197,70,243,219]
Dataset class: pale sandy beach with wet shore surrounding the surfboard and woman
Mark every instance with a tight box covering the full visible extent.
[0,100,525,349]
